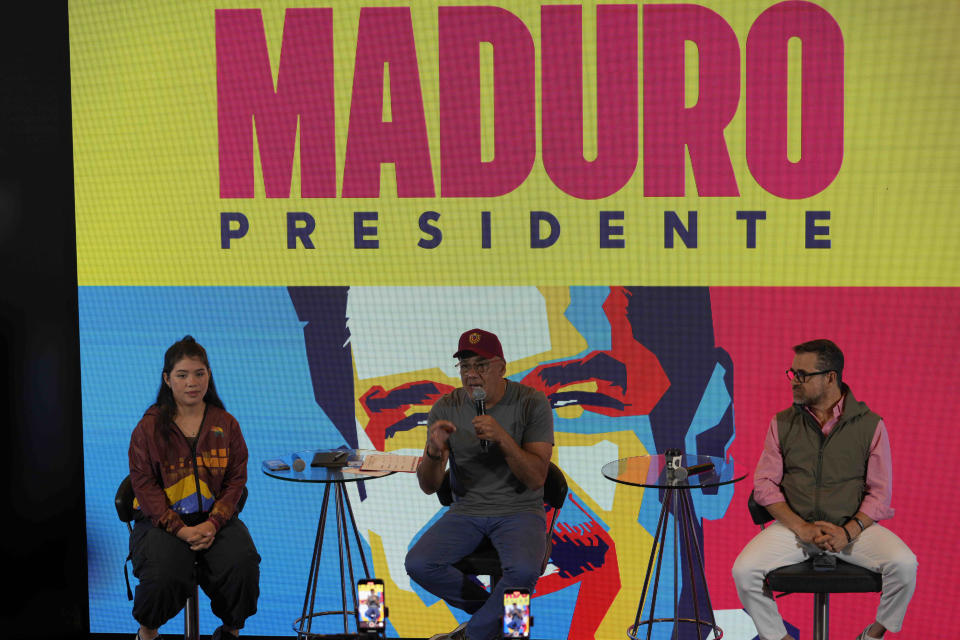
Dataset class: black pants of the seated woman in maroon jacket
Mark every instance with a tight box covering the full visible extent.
[130,518,260,629]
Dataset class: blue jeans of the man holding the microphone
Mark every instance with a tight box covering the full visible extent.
[406,511,546,640]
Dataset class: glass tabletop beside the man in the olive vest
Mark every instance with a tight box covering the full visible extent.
[601,453,747,489]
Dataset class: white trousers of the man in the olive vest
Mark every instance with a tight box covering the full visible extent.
[733,522,917,640]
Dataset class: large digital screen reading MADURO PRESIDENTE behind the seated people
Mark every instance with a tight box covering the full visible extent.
[70,0,960,640]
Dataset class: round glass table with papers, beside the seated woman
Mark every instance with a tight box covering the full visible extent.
[260,449,392,639]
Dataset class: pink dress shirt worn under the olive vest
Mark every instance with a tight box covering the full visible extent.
[753,395,894,521]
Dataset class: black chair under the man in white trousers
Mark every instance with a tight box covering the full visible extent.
[747,492,883,640]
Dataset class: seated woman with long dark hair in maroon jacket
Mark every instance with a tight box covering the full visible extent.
[129,336,260,640]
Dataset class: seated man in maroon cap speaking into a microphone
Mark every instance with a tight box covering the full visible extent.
[406,329,553,640]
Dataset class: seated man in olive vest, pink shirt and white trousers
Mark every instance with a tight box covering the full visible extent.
[733,340,917,640]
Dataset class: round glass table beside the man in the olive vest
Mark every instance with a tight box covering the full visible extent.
[601,454,747,640]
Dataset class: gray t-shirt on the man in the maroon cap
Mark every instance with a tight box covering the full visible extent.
[428,380,553,516]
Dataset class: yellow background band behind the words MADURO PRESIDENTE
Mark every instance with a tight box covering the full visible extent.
[69,0,960,286]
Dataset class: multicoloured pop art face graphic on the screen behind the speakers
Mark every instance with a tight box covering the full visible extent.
[289,287,734,638]
